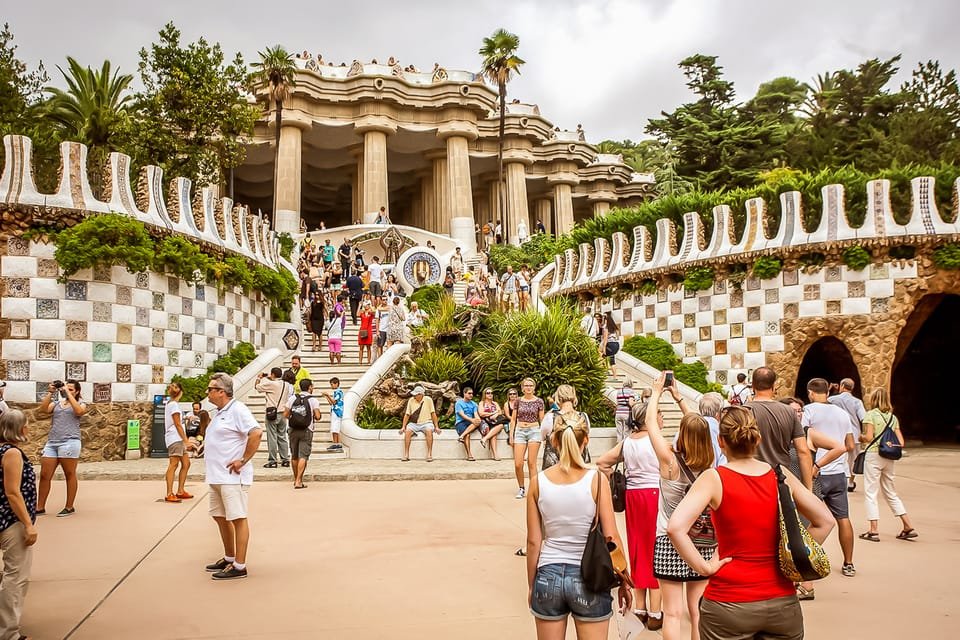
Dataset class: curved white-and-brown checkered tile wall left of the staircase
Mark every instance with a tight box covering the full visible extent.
[0,238,269,402]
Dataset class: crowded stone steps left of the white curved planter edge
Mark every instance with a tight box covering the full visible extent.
[244,318,376,464]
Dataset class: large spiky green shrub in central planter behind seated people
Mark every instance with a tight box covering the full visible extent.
[467,301,607,410]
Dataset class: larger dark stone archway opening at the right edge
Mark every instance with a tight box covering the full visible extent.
[890,294,960,441]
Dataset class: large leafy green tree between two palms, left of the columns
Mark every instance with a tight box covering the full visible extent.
[128,22,260,185]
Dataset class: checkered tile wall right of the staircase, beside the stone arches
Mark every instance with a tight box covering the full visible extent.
[601,263,917,385]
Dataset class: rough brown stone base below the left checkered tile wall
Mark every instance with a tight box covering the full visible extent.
[11,400,153,462]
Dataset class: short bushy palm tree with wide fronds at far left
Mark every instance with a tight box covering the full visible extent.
[43,56,133,196]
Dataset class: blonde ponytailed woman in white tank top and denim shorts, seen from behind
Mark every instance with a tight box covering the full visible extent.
[527,411,632,640]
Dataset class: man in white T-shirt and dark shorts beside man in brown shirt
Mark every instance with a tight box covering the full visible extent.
[801,378,857,578]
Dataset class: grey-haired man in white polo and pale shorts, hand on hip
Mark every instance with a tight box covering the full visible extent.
[204,373,263,580]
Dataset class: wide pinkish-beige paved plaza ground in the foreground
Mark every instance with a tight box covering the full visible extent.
[23,449,960,640]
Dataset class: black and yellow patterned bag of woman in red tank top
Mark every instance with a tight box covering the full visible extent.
[773,465,830,582]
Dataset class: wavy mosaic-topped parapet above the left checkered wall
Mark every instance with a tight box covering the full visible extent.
[0,135,292,270]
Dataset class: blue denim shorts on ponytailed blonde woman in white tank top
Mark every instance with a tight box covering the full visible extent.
[530,564,613,622]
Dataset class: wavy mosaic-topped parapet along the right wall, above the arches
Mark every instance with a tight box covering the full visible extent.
[540,177,960,297]
